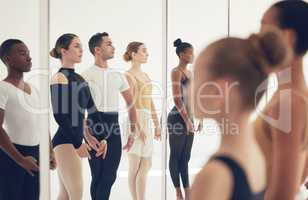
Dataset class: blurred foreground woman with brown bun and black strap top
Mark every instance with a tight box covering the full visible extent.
[192,29,289,200]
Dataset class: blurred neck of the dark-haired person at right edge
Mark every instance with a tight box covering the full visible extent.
[277,57,306,90]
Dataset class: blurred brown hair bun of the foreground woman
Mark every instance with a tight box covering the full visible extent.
[248,29,289,71]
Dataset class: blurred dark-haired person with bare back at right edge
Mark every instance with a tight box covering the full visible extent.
[255,0,308,200]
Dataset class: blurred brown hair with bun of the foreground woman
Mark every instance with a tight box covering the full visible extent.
[196,28,289,109]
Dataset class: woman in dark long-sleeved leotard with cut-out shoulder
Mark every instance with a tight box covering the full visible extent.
[51,34,105,200]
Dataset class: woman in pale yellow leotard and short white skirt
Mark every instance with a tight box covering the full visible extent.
[123,42,161,200]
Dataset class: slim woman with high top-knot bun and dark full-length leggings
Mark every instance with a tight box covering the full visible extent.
[168,39,201,199]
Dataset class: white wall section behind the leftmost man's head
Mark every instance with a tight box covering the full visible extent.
[0,0,39,79]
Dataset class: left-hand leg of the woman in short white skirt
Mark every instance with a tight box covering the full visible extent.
[128,154,141,200]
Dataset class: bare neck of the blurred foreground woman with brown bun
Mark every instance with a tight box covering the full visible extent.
[215,114,256,154]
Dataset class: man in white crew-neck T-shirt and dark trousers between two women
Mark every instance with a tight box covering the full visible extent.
[83,32,140,200]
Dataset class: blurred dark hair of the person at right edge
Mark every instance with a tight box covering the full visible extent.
[273,0,308,55]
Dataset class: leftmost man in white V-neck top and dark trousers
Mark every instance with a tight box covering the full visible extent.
[0,39,55,200]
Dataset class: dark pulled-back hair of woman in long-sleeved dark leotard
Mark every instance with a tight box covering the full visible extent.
[49,33,78,59]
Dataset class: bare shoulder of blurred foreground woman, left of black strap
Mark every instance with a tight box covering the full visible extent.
[192,160,233,200]
